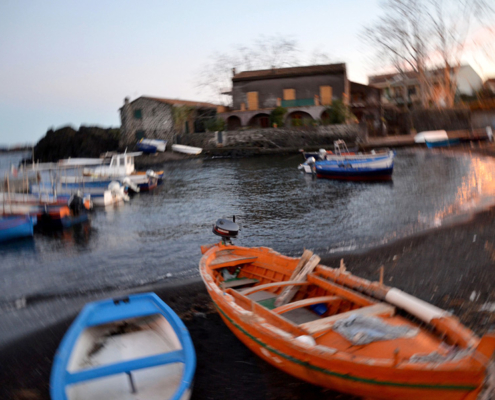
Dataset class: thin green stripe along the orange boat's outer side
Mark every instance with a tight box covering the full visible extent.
[215,304,477,391]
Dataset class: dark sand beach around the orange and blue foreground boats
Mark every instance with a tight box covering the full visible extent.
[0,147,495,400]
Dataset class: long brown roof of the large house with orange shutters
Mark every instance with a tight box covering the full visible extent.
[232,64,345,82]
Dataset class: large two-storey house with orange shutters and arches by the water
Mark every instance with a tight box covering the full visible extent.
[218,64,350,130]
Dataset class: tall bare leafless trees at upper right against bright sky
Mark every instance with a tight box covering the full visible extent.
[363,0,493,107]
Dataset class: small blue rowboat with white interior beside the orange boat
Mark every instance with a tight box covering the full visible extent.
[50,293,196,400]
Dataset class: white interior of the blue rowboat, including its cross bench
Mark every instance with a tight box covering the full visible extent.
[67,314,184,400]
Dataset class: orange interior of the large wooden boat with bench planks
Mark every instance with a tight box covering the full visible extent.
[207,247,478,363]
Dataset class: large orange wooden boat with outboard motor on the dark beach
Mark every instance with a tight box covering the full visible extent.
[199,220,495,400]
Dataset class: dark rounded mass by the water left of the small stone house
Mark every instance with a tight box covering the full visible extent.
[34,126,120,162]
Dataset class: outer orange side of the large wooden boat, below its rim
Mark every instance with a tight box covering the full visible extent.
[211,290,484,400]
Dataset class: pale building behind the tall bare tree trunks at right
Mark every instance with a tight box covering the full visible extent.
[368,65,483,107]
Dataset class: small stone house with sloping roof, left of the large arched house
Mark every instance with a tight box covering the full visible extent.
[119,96,217,147]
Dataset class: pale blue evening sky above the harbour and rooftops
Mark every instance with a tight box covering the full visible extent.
[0,0,495,145]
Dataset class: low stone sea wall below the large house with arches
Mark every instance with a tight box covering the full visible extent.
[180,124,360,152]
